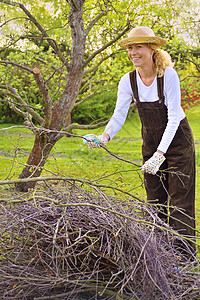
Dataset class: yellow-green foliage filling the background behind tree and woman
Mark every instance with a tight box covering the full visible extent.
[0,0,199,123]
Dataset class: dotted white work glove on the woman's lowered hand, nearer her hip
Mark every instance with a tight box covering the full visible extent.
[141,152,166,175]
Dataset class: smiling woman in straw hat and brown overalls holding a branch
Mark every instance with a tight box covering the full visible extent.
[83,27,195,255]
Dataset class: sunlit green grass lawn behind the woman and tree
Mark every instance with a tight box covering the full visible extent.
[0,106,200,245]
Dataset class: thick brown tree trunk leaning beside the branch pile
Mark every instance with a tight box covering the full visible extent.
[16,0,85,192]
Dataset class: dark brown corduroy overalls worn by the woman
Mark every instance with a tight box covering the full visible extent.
[130,70,195,253]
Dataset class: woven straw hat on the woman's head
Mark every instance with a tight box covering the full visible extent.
[119,26,166,49]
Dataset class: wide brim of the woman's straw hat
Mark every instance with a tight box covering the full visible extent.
[118,36,166,49]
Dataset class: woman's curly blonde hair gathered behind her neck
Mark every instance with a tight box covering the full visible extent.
[148,44,174,77]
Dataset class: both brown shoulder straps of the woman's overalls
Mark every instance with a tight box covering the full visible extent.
[129,70,165,103]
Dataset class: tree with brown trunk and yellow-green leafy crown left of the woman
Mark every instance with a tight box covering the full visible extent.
[0,0,199,191]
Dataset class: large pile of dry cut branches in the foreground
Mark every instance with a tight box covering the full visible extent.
[0,183,200,300]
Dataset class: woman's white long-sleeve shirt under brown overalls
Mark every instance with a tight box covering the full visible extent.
[104,67,185,153]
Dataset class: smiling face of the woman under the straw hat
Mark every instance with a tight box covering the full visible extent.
[128,44,154,68]
